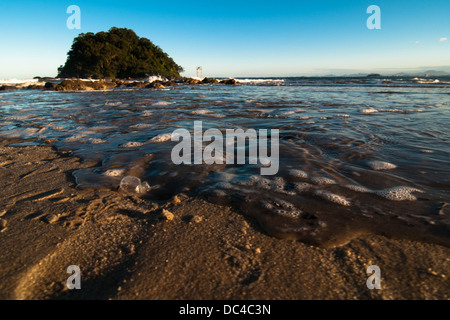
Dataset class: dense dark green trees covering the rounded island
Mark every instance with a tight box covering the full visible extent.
[58,27,183,78]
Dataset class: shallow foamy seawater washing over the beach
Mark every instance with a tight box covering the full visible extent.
[0,78,450,245]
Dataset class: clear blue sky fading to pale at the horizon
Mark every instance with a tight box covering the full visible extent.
[0,0,450,79]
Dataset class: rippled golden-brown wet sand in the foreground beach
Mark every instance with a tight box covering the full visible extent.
[0,140,450,300]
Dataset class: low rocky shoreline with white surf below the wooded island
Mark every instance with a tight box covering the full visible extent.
[0,78,239,91]
